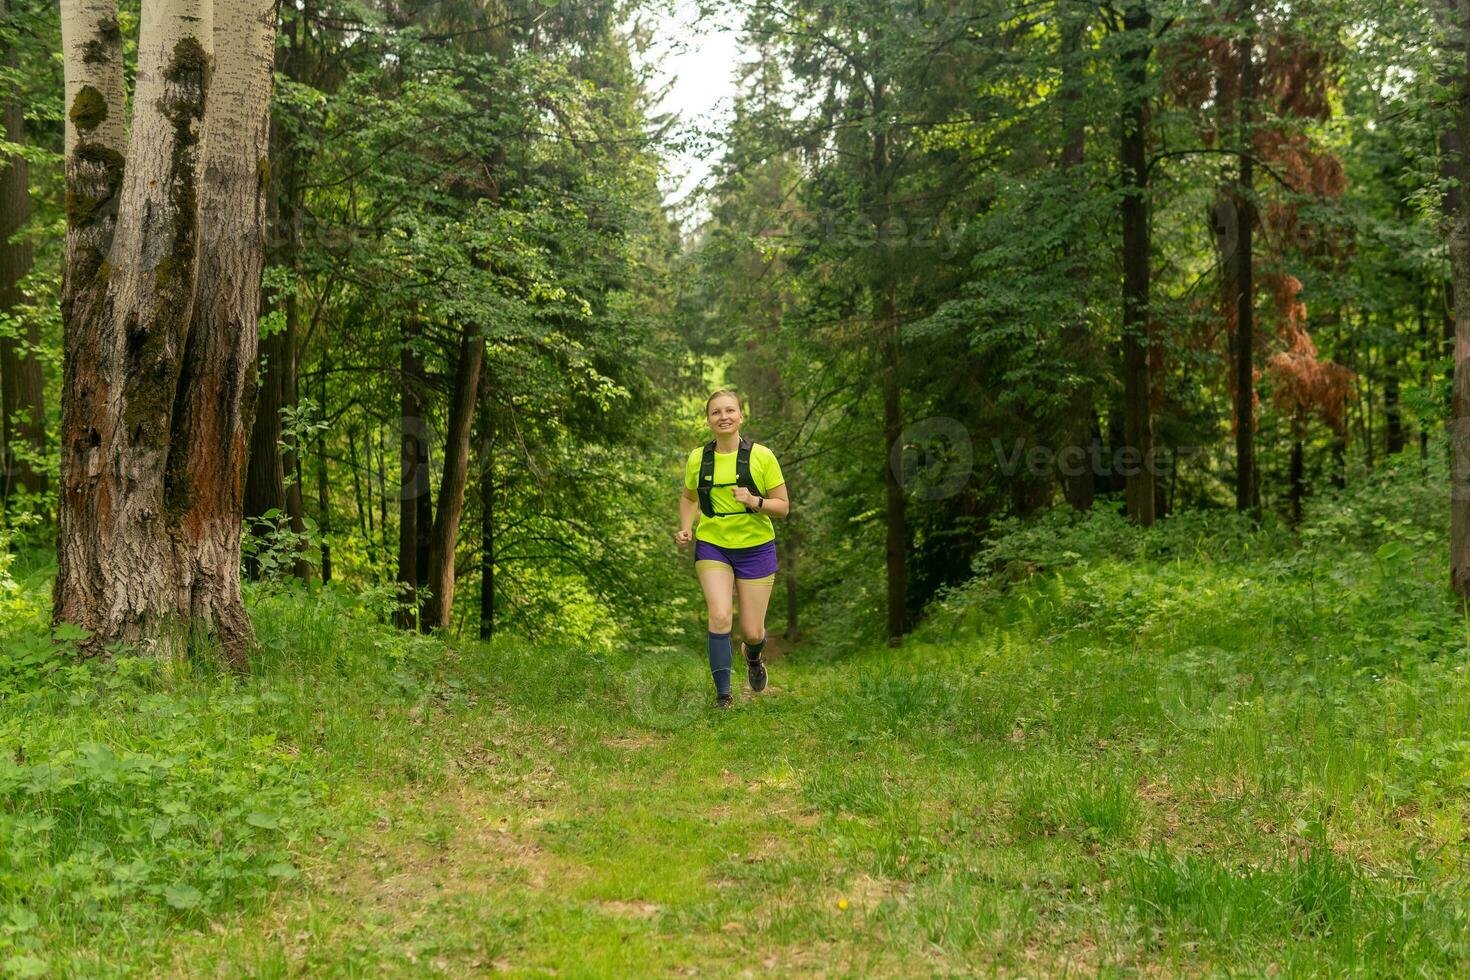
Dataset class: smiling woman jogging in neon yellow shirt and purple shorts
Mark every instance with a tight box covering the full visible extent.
[675,389,791,708]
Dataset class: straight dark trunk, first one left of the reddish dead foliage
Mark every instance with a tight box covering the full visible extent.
[1120,4,1154,527]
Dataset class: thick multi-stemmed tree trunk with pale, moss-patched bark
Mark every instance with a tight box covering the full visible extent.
[53,0,275,666]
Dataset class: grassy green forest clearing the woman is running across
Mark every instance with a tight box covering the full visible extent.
[0,499,1470,977]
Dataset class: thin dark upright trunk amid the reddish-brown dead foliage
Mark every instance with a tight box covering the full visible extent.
[1235,0,1255,511]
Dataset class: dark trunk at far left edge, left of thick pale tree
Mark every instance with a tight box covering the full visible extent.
[0,73,49,504]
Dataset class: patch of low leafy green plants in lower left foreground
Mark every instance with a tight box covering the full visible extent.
[0,645,320,952]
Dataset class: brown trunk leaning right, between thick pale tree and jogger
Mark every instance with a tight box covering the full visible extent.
[426,325,485,627]
